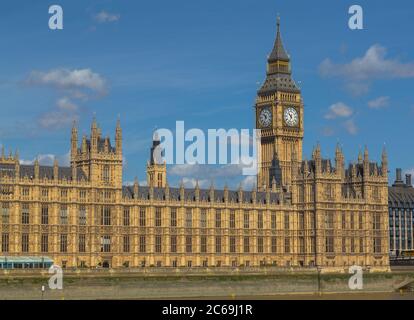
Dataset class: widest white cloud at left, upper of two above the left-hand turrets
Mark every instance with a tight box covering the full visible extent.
[26,68,107,95]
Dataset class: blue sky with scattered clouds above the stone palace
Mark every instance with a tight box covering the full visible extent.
[0,0,414,186]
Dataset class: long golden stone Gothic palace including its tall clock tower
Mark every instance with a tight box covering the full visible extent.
[0,18,390,272]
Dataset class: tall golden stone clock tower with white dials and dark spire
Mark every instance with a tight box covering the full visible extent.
[255,17,303,190]
